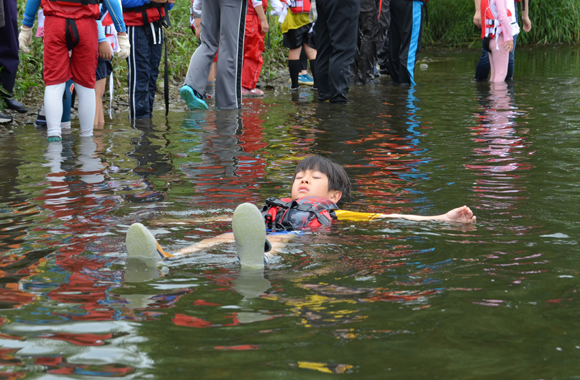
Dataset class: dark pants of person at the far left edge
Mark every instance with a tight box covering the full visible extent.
[0,0,19,97]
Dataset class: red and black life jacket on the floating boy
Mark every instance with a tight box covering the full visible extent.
[262,196,338,231]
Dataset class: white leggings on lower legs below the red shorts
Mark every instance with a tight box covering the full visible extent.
[44,83,96,137]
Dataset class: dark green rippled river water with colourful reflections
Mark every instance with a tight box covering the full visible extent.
[0,47,580,379]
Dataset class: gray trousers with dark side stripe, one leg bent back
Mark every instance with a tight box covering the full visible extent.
[185,0,248,109]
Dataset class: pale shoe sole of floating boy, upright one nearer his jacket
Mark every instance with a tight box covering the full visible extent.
[232,203,266,268]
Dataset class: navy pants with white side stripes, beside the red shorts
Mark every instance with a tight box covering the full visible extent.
[127,23,163,119]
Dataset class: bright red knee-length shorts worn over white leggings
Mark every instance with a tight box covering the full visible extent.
[43,16,99,88]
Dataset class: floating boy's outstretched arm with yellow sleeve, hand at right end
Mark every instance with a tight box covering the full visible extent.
[334,206,476,223]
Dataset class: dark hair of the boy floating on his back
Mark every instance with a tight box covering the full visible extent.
[293,155,352,206]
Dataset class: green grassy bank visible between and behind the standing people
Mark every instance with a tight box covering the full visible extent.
[7,0,580,107]
